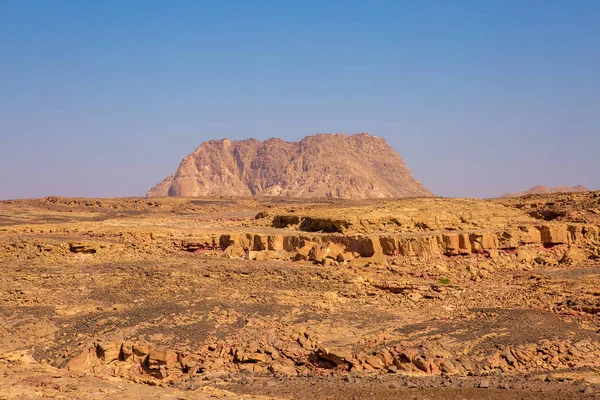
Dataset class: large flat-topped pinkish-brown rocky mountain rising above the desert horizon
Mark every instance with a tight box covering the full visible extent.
[147,133,433,199]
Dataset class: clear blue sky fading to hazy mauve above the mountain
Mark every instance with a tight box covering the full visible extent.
[0,0,600,199]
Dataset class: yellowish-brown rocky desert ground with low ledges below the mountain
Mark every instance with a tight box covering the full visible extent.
[0,192,600,399]
